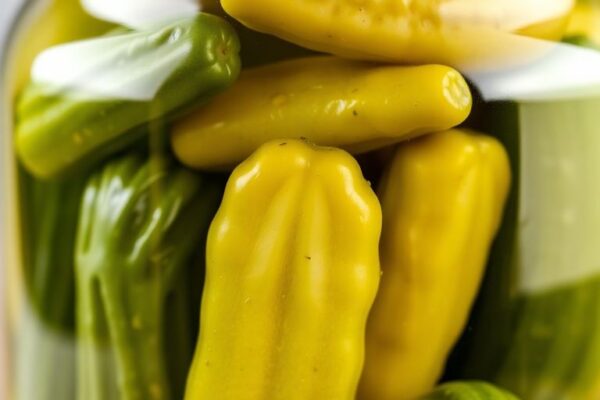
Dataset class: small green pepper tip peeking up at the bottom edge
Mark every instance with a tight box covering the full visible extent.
[421,381,518,400]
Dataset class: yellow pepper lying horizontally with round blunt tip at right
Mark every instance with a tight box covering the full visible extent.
[172,57,471,169]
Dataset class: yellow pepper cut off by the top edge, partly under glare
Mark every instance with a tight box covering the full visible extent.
[221,0,574,66]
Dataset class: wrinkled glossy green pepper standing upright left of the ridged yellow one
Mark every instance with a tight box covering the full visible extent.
[75,154,221,400]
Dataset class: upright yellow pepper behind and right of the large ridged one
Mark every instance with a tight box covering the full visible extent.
[359,130,510,400]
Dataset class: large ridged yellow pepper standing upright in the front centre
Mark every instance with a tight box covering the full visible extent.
[185,140,381,400]
